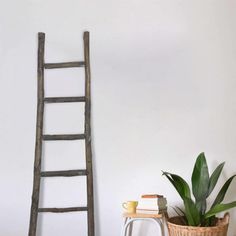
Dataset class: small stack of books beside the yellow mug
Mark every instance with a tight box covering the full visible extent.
[137,194,167,211]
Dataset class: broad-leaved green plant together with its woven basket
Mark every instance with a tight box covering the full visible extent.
[163,153,236,236]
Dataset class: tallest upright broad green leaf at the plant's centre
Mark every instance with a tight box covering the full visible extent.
[192,153,209,202]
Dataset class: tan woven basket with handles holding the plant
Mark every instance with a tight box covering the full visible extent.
[167,213,229,236]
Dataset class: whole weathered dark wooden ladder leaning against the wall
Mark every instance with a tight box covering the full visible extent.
[28,32,95,236]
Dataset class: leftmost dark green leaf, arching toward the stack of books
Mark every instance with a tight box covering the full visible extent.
[163,172,191,200]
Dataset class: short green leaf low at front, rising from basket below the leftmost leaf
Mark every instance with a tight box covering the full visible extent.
[184,198,200,226]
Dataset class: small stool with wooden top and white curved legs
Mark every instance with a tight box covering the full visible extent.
[122,211,168,236]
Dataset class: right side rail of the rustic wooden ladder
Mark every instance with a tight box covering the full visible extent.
[84,32,95,236]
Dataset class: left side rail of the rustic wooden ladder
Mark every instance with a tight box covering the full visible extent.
[28,33,45,236]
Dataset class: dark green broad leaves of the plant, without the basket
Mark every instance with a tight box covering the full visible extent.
[163,153,236,227]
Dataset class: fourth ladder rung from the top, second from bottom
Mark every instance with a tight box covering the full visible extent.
[41,170,87,177]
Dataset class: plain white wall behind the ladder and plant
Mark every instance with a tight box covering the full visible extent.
[0,0,236,236]
